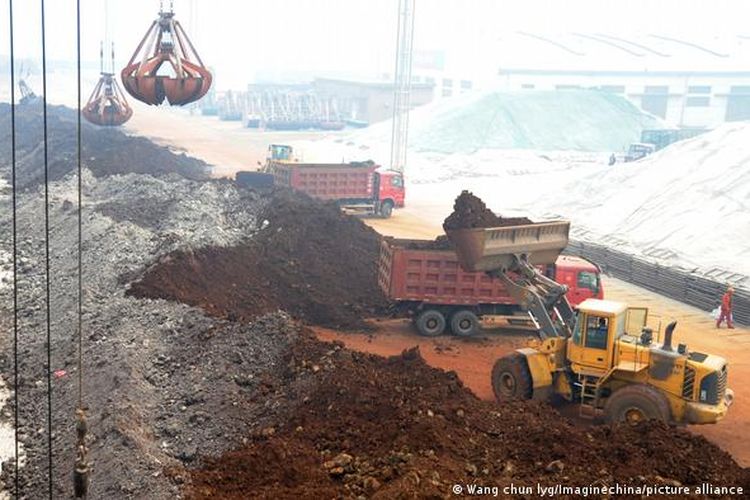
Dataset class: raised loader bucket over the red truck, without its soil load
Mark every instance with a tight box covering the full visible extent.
[446,221,570,271]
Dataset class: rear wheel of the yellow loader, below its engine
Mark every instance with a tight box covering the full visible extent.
[604,384,670,425]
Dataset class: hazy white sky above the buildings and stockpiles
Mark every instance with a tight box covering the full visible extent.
[0,0,750,89]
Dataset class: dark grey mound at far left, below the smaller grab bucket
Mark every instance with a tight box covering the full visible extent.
[0,104,210,188]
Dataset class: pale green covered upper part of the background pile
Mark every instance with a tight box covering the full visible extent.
[324,90,664,154]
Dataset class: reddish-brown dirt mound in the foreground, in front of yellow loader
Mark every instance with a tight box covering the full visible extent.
[187,337,750,499]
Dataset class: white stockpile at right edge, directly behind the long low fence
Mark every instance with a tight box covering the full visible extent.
[540,123,750,282]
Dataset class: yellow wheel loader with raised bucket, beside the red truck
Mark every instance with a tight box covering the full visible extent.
[446,221,733,424]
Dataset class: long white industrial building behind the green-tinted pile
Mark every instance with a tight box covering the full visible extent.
[414,31,750,128]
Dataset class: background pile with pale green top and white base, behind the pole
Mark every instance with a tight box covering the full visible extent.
[293,90,640,185]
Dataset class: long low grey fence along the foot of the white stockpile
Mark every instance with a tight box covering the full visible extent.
[565,241,750,325]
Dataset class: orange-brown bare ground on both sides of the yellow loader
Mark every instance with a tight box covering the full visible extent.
[315,278,750,467]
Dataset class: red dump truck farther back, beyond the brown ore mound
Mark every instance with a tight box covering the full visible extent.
[264,145,405,217]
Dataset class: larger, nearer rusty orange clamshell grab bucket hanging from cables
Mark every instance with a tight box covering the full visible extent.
[120,11,212,106]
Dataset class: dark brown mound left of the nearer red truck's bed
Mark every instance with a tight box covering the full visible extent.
[128,190,386,328]
